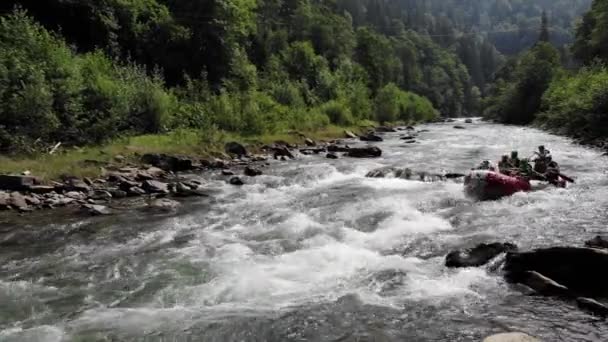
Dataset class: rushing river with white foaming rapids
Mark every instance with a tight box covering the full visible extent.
[0,122,608,342]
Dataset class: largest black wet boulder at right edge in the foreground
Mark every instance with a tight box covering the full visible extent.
[505,247,608,297]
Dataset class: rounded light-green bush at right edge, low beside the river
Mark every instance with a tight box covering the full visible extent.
[537,66,608,138]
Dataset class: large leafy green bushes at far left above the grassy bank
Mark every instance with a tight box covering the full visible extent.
[0,12,175,150]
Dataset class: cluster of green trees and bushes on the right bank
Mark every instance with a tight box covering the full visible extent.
[485,0,608,141]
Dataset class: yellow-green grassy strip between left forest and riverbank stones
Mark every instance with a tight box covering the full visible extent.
[0,126,361,181]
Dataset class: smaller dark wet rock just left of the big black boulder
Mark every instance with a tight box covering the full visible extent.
[445,242,517,268]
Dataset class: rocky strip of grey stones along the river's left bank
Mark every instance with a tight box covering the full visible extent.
[0,127,394,215]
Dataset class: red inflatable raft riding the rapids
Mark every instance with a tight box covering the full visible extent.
[464,170,532,201]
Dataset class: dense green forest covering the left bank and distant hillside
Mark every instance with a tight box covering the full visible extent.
[0,0,605,152]
